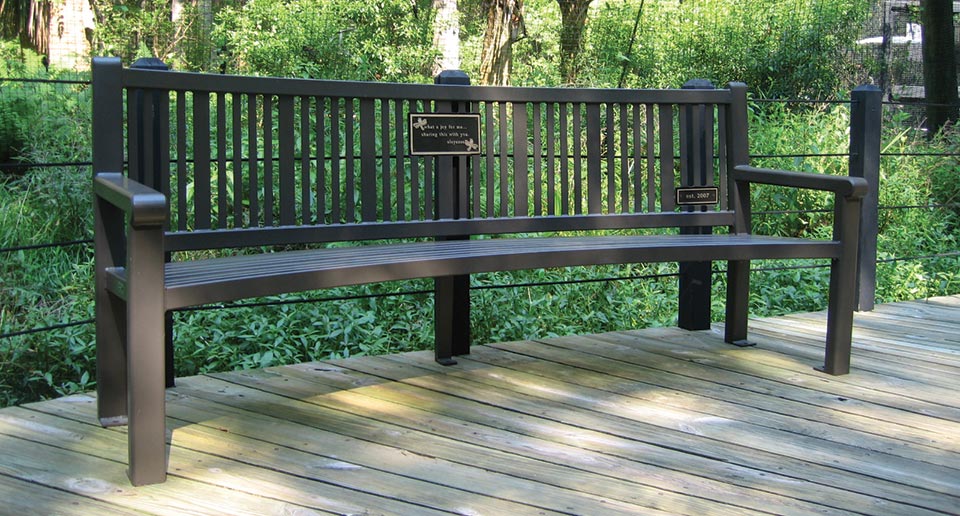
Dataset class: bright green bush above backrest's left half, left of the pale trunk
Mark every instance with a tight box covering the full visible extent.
[214,0,435,82]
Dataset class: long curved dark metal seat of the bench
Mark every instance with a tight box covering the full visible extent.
[159,235,840,309]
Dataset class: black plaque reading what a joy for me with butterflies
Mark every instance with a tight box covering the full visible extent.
[410,113,480,156]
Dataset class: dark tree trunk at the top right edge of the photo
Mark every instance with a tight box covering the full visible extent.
[920,0,958,137]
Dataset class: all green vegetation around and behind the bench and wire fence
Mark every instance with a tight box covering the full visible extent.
[0,0,960,406]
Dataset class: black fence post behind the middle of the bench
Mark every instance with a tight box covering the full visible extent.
[433,70,470,365]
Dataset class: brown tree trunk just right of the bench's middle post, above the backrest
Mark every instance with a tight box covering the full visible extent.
[480,0,523,86]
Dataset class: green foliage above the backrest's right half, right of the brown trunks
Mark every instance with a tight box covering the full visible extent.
[583,0,869,98]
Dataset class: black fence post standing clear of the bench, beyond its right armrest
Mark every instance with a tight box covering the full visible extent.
[849,85,883,311]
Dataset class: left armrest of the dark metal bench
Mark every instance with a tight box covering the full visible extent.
[93,172,167,228]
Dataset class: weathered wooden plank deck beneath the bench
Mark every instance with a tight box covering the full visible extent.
[0,296,960,516]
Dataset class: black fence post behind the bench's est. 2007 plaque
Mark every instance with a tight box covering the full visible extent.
[677,79,715,330]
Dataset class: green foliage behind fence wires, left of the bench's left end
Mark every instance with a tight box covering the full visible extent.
[0,45,93,405]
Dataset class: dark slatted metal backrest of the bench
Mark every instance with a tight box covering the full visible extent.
[93,58,747,251]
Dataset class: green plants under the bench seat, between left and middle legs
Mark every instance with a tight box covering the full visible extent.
[174,282,433,375]
